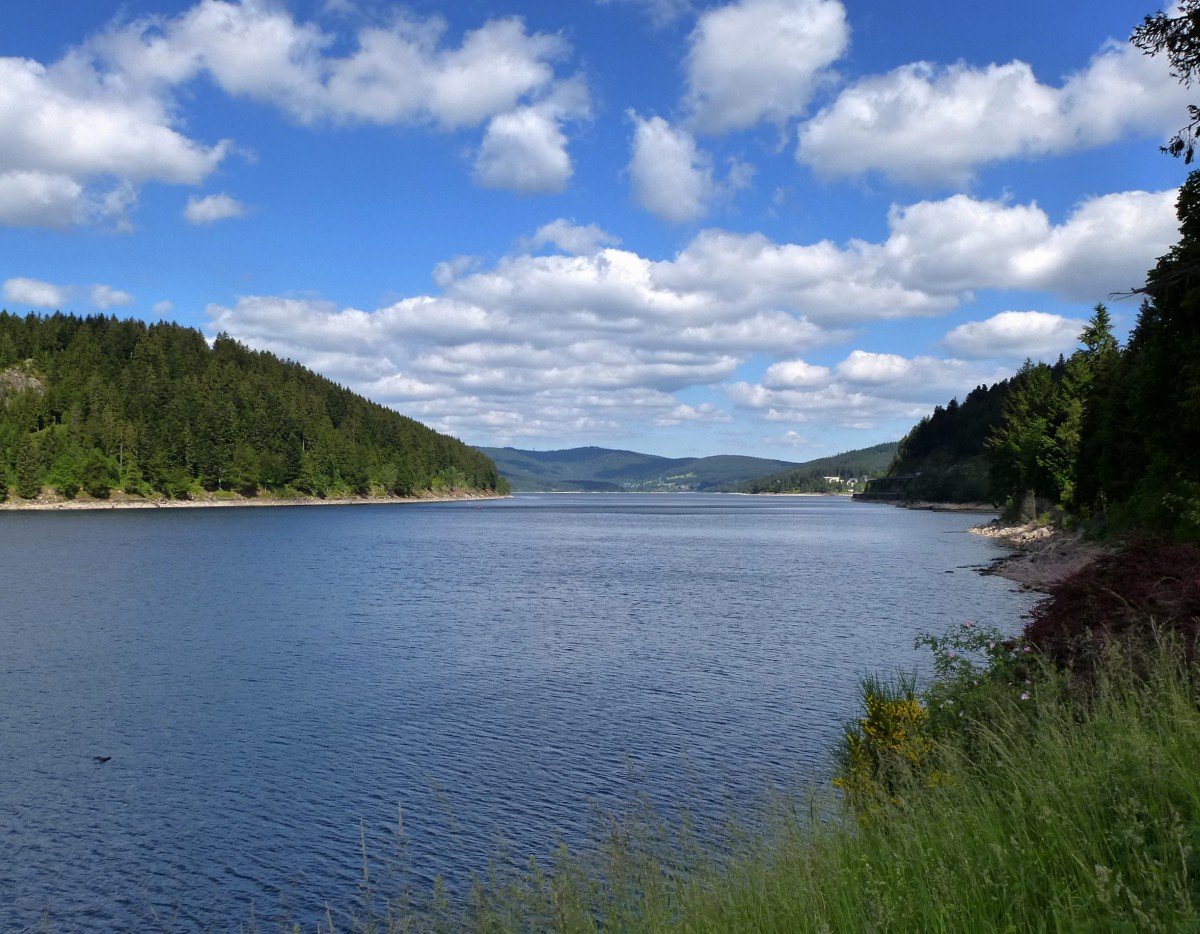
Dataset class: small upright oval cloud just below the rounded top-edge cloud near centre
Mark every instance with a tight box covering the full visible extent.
[629,113,716,223]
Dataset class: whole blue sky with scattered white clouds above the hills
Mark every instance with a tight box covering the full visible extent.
[0,0,1193,461]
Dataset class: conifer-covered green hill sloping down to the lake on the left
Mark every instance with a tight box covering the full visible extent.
[0,311,506,498]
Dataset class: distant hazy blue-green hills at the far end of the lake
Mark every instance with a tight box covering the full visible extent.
[478,444,895,492]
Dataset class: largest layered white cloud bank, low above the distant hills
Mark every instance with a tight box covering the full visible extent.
[209,184,1175,439]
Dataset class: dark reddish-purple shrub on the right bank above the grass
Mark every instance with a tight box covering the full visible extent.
[1025,539,1200,670]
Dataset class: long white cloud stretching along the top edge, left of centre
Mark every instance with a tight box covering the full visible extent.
[102,0,578,136]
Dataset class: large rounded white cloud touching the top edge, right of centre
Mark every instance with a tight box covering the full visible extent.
[684,0,850,133]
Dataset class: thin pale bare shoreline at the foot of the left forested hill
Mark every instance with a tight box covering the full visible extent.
[0,491,509,513]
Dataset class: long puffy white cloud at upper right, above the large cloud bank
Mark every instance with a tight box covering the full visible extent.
[797,42,1188,186]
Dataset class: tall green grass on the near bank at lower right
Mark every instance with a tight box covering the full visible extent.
[322,641,1200,934]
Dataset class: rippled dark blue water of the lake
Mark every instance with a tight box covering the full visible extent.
[0,495,1031,932]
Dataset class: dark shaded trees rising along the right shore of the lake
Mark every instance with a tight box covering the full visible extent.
[889,173,1200,540]
